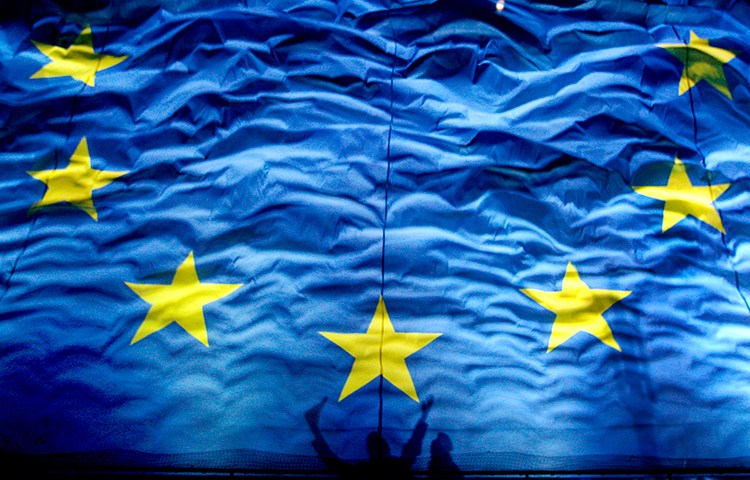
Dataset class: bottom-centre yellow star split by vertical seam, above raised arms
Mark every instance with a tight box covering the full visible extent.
[319,296,441,402]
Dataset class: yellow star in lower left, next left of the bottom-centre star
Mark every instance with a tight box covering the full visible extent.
[125,252,242,346]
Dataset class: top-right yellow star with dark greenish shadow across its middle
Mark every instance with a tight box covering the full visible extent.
[658,30,737,100]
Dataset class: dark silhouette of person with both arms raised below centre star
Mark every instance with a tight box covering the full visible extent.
[305,397,433,480]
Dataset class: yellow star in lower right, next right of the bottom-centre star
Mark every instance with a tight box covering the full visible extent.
[521,263,631,353]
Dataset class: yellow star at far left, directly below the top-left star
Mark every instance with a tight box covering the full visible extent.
[26,137,128,220]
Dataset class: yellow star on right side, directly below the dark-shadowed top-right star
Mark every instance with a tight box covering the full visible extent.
[633,157,730,233]
